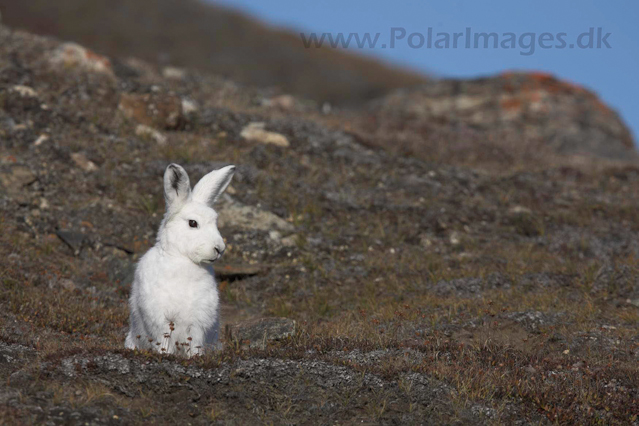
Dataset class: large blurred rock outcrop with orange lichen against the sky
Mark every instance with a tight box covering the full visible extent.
[364,73,636,159]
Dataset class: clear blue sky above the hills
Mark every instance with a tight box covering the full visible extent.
[215,0,639,146]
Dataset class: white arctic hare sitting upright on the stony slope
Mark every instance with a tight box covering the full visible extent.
[125,164,235,357]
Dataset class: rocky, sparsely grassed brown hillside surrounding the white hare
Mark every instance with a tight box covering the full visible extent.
[0,27,639,425]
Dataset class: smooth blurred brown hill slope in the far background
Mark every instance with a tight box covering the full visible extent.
[0,0,425,104]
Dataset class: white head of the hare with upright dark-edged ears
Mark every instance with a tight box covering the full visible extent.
[158,164,235,263]
